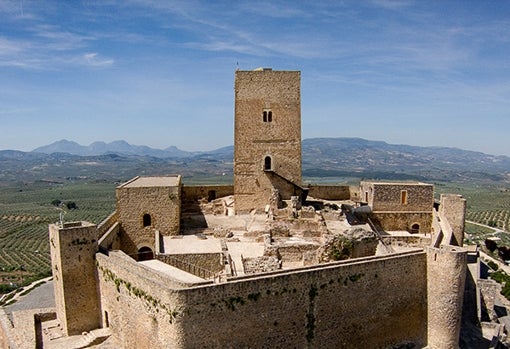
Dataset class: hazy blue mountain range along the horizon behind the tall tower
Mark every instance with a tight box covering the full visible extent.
[0,138,510,182]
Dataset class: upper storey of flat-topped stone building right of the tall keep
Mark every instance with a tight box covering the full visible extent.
[360,182,434,213]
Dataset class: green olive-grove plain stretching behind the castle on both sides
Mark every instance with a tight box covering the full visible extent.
[0,176,510,291]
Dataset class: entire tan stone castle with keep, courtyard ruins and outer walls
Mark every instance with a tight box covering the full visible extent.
[0,68,482,349]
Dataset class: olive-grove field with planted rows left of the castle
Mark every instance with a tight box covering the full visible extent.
[0,182,115,292]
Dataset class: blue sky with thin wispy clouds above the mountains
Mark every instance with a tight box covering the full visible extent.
[0,0,510,156]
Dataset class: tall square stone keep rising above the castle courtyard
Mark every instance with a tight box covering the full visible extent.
[234,68,302,212]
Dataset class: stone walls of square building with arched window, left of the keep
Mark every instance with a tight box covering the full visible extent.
[116,182,181,255]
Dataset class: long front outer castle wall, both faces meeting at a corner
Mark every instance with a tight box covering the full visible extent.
[97,251,427,348]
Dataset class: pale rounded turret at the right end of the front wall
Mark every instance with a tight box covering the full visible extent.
[427,246,467,349]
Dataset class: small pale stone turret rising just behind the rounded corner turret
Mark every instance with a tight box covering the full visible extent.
[439,194,466,246]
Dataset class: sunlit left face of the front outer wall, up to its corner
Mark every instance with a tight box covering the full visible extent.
[96,251,211,349]
